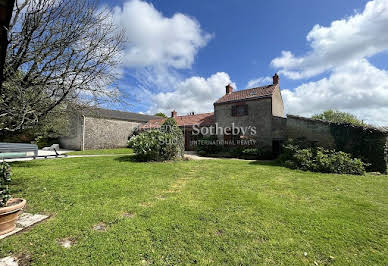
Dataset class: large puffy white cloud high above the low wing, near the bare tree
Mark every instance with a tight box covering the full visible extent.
[113,0,211,69]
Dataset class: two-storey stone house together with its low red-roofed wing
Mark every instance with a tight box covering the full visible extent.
[142,74,286,153]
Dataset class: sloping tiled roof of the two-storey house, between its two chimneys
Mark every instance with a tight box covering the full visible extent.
[215,85,277,104]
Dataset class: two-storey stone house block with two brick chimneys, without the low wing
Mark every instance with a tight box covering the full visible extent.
[214,74,285,152]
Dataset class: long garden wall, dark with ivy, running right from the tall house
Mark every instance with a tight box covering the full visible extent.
[287,115,388,173]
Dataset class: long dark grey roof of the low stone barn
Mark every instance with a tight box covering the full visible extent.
[82,108,157,122]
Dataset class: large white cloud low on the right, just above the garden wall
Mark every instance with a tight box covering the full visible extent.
[282,59,388,126]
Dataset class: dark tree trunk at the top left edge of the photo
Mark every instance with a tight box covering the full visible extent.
[0,0,15,90]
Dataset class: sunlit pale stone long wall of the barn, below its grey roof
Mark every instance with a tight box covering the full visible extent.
[83,117,141,150]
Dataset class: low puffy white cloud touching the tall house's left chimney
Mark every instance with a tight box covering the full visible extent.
[148,72,235,115]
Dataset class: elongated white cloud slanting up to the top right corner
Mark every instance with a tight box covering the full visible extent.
[271,0,388,79]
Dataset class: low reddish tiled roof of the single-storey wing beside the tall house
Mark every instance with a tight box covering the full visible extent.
[141,113,214,129]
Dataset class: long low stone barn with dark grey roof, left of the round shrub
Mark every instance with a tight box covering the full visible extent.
[59,108,157,150]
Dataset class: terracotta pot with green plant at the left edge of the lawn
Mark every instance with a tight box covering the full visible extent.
[0,162,26,235]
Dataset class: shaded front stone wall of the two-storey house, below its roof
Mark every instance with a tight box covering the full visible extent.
[214,98,272,149]
